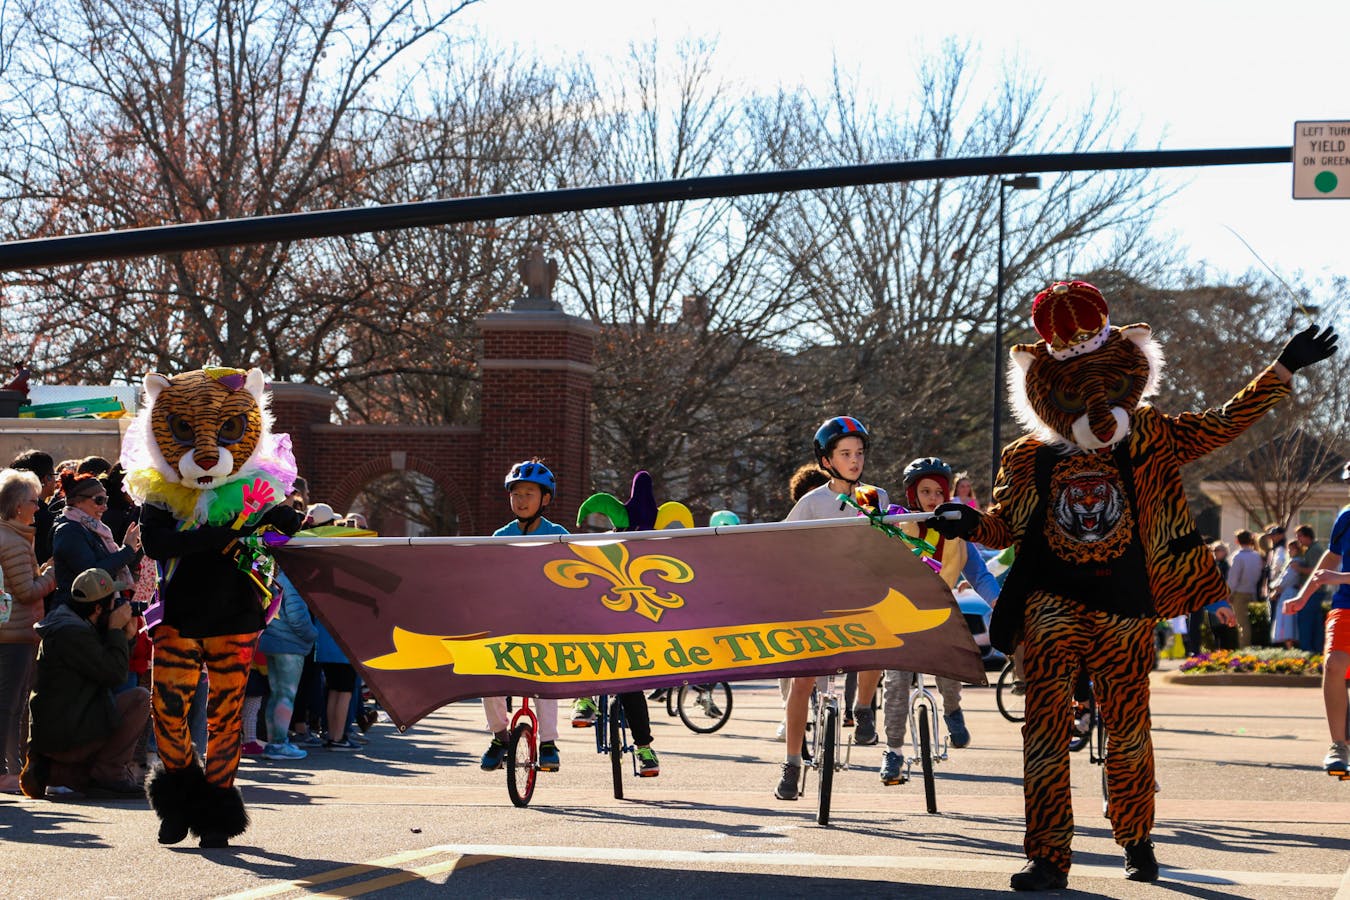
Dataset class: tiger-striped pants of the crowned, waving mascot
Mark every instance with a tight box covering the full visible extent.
[1019,591,1154,872]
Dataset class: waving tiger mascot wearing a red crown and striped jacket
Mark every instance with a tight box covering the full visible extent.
[932,281,1335,891]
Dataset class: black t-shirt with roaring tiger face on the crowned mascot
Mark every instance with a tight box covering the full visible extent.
[1038,452,1153,617]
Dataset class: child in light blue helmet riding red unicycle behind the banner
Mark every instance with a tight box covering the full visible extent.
[479,459,567,772]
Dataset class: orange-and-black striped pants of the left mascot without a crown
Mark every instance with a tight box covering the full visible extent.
[151,623,258,788]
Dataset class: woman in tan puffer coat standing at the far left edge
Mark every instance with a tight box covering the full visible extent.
[0,468,57,793]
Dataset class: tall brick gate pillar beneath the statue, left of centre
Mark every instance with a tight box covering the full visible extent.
[478,310,599,533]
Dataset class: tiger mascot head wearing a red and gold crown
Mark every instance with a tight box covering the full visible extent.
[1008,281,1162,451]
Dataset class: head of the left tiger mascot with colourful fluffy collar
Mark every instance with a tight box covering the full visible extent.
[122,367,296,524]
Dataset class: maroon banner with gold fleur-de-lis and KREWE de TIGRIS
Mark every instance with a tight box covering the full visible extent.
[275,522,984,727]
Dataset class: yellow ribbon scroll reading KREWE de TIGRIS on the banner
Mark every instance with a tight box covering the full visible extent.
[363,588,952,683]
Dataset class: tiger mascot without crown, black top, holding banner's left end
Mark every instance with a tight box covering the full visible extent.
[122,368,302,847]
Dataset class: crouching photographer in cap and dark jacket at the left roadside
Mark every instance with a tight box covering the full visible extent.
[19,568,150,799]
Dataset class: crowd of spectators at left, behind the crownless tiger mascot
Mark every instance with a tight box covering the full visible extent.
[0,451,378,799]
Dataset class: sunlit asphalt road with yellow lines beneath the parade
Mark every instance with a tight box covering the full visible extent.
[0,661,1350,900]
